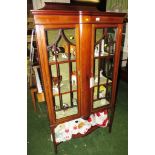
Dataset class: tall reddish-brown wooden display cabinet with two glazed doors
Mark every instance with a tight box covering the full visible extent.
[32,3,125,151]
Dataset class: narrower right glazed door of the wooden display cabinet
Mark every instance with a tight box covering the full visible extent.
[90,25,119,111]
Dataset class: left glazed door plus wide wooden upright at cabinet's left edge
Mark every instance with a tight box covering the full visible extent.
[36,25,80,122]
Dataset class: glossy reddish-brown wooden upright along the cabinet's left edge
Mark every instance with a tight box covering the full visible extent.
[36,25,55,124]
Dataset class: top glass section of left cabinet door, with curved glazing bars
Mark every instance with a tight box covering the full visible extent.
[45,29,76,62]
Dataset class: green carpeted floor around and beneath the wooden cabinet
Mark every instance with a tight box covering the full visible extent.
[27,81,128,155]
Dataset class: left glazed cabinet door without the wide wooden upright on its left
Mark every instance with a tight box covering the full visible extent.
[41,25,80,120]
